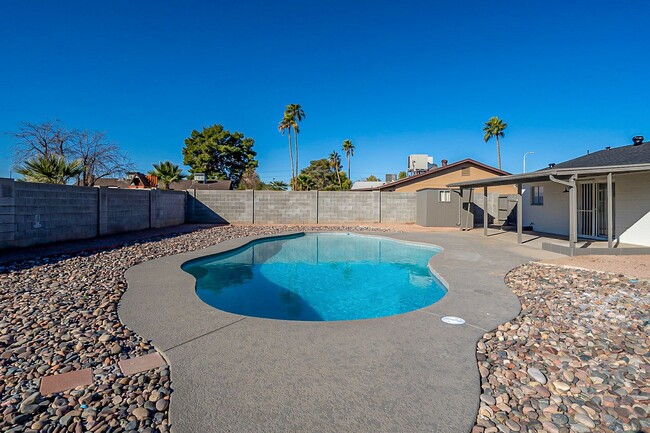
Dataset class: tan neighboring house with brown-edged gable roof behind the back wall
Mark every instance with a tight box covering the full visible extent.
[374,158,516,194]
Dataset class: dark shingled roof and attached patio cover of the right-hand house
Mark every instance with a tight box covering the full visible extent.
[447,142,650,188]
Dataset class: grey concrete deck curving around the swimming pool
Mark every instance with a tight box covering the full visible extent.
[118,232,560,432]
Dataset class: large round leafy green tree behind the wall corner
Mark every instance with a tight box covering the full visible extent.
[183,125,258,188]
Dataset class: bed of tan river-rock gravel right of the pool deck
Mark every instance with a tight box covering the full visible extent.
[472,263,650,433]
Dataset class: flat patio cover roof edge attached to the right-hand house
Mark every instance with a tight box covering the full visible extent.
[447,164,650,188]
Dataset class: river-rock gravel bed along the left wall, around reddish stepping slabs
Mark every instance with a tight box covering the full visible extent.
[0,226,386,433]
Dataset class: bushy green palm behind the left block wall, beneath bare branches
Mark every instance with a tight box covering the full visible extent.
[16,153,84,185]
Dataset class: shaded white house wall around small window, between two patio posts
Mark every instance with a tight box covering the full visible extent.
[515,182,569,235]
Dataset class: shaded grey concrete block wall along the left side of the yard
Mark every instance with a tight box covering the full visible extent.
[0,178,186,250]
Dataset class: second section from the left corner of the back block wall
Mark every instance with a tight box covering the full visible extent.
[253,191,322,224]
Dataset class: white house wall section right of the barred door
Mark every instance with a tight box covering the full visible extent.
[614,173,650,246]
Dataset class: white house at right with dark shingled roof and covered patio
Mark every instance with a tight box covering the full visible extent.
[449,136,650,250]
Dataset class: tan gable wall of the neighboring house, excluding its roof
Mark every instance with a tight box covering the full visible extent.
[383,163,517,194]
